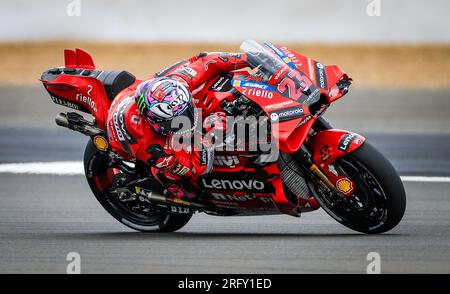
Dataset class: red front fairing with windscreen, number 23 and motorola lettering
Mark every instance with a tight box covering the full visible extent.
[232,41,349,154]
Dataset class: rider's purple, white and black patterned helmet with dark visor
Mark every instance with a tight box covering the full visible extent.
[135,77,197,135]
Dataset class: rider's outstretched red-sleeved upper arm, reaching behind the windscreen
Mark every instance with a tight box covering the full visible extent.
[170,52,248,91]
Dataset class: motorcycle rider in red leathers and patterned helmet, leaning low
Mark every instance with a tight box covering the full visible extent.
[107,52,248,198]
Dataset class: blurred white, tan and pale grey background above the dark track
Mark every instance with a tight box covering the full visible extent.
[0,0,450,133]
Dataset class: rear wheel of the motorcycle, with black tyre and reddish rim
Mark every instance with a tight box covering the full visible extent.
[84,140,192,232]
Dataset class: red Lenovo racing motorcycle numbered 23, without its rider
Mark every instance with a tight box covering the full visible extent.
[41,41,406,234]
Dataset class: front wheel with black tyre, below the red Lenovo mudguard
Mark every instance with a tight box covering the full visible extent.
[314,141,406,234]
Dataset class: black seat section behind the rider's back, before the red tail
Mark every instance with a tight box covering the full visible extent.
[97,70,136,100]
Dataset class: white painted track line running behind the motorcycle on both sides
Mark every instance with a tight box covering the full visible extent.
[0,161,450,183]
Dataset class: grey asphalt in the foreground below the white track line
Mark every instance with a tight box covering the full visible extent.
[0,174,450,274]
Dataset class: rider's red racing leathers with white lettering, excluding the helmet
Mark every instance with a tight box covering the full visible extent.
[106,52,248,197]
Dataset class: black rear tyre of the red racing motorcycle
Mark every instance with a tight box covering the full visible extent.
[84,140,192,232]
